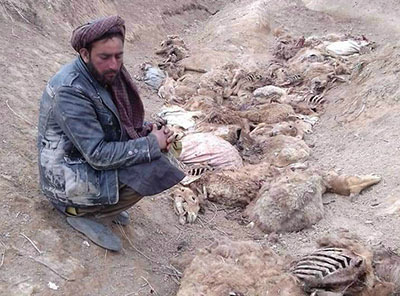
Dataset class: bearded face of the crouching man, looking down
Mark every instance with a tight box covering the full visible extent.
[81,37,124,85]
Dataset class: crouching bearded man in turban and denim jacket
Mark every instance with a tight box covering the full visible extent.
[38,16,184,251]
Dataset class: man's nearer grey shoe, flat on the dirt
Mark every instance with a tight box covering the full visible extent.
[67,217,122,252]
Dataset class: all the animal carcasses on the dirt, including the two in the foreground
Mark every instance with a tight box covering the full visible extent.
[138,33,400,296]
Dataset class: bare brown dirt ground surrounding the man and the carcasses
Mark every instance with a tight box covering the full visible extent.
[0,0,400,295]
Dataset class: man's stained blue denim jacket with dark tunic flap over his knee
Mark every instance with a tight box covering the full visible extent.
[37,58,184,206]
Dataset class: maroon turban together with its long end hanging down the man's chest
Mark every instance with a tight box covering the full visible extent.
[71,16,145,139]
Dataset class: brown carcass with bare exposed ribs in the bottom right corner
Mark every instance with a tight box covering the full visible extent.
[291,232,394,296]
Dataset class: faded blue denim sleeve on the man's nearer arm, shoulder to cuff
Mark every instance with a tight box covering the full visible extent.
[53,86,161,170]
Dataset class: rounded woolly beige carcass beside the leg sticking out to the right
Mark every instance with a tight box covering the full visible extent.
[246,170,324,233]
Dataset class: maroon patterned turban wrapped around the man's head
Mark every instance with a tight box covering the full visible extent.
[71,15,125,52]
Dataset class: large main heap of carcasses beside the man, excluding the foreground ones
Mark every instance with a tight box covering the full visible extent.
[143,33,380,232]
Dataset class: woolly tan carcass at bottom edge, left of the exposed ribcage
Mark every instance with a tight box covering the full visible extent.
[177,240,306,296]
